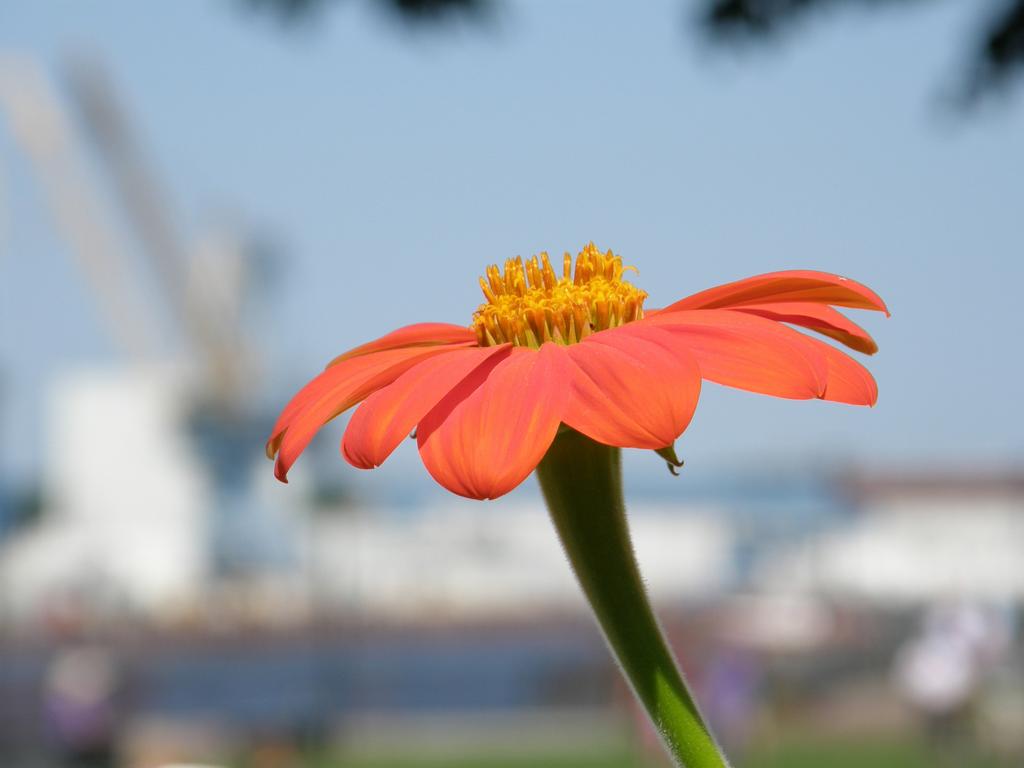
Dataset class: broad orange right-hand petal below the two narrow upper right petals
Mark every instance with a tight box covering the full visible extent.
[637,309,828,399]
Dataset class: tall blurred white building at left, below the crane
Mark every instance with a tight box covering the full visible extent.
[0,366,210,617]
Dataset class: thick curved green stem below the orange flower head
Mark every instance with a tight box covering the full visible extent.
[537,427,728,768]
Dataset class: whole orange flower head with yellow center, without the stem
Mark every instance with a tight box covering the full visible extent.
[266,244,888,499]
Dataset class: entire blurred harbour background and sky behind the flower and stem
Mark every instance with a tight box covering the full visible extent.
[0,0,1024,768]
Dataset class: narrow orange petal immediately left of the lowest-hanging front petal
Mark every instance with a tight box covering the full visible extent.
[341,345,510,469]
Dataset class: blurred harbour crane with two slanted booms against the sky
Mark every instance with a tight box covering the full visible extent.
[0,57,287,573]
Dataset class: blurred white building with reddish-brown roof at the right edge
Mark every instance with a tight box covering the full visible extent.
[760,471,1024,605]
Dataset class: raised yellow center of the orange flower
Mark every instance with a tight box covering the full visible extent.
[473,243,647,348]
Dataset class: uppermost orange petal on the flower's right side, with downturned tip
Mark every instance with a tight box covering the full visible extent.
[663,269,889,314]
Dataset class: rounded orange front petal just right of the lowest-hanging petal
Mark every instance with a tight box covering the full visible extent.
[562,324,700,451]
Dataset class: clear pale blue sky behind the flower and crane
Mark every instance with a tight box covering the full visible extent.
[0,0,1024,489]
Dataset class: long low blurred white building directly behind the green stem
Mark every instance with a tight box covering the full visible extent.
[309,498,732,618]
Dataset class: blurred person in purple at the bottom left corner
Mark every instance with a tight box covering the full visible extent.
[43,647,120,768]
